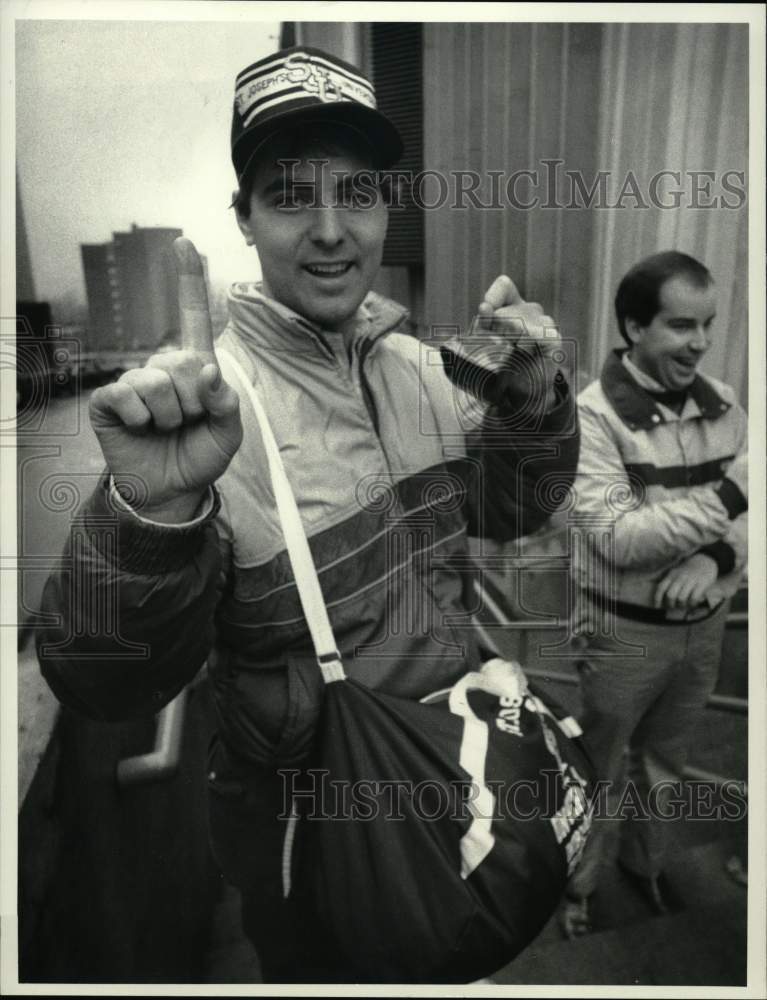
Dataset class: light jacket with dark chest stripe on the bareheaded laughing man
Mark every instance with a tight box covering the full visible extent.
[573,350,747,617]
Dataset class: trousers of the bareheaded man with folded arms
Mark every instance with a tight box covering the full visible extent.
[568,603,728,896]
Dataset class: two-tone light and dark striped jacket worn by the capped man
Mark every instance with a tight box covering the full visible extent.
[38,285,578,763]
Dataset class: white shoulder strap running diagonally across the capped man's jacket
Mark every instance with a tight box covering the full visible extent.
[216,350,346,684]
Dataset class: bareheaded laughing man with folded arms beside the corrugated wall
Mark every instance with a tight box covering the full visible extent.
[562,251,748,937]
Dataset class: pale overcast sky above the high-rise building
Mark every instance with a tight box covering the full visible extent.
[16,20,279,302]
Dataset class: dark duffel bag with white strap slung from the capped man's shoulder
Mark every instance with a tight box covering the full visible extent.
[221,352,593,983]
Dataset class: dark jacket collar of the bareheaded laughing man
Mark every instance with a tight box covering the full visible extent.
[600,347,730,431]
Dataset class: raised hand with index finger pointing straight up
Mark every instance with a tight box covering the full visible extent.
[90,237,242,523]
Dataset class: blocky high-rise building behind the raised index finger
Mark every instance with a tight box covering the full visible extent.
[80,223,182,351]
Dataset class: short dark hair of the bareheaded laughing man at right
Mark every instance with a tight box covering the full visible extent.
[615,250,714,345]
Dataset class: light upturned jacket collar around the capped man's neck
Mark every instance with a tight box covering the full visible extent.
[229,282,408,355]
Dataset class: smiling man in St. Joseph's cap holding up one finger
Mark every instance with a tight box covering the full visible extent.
[38,48,578,982]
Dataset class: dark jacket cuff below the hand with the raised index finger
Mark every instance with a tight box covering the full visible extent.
[82,475,221,576]
